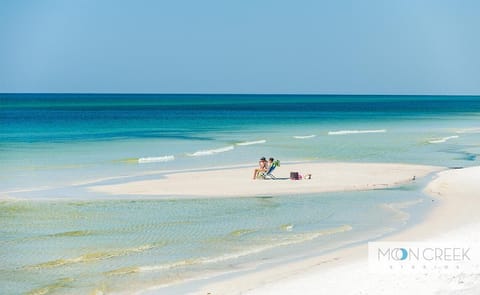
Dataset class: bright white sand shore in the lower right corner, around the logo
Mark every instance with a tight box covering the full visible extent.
[191,167,480,295]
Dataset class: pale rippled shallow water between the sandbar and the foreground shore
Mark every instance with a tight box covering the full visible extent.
[0,186,436,294]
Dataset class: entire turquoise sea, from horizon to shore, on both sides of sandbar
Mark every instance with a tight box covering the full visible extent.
[0,94,480,294]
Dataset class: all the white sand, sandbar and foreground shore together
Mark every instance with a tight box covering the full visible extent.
[7,163,480,295]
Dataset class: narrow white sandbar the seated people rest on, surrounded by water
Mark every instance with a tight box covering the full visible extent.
[89,163,442,198]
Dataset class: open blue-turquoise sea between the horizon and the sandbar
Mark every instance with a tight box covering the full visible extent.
[0,94,480,192]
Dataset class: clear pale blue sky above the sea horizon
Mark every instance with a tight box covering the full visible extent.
[0,0,480,95]
